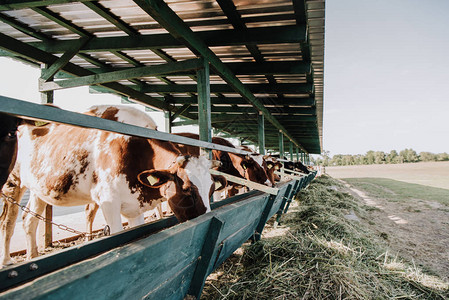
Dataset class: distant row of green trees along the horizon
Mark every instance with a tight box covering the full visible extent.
[311,149,449,166]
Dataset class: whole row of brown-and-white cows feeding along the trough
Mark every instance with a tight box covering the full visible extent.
[0,105,309,266]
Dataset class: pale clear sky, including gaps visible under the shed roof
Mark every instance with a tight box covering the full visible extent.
[0,0,449,155]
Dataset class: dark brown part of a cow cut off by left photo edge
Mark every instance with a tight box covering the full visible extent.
[0,114,20,188]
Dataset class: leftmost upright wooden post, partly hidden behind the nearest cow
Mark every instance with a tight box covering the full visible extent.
[38,64,54,249]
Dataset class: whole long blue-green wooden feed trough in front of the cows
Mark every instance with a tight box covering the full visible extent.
[0,182,294,299]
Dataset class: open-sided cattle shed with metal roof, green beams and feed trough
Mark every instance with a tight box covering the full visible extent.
[0,0,325,299]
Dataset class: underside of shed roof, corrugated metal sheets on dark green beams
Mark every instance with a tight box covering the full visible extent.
[0,0,325,153]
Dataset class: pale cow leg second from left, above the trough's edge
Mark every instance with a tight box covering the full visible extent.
[22,192,46,259]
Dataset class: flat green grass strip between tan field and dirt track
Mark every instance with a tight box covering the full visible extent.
[342,178,449,206]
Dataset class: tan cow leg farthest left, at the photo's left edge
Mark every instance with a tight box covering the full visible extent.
[0,175,26,267]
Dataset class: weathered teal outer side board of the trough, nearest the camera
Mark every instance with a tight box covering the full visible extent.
[1,189,267,299]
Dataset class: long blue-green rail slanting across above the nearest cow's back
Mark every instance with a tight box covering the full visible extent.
[0,96,249,154]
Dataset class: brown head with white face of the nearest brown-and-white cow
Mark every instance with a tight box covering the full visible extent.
[138,156,220,222]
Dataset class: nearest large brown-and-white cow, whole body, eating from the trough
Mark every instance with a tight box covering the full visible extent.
[0,106,214,265]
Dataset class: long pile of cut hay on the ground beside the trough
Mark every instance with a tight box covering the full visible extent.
[202,177,449,299]
